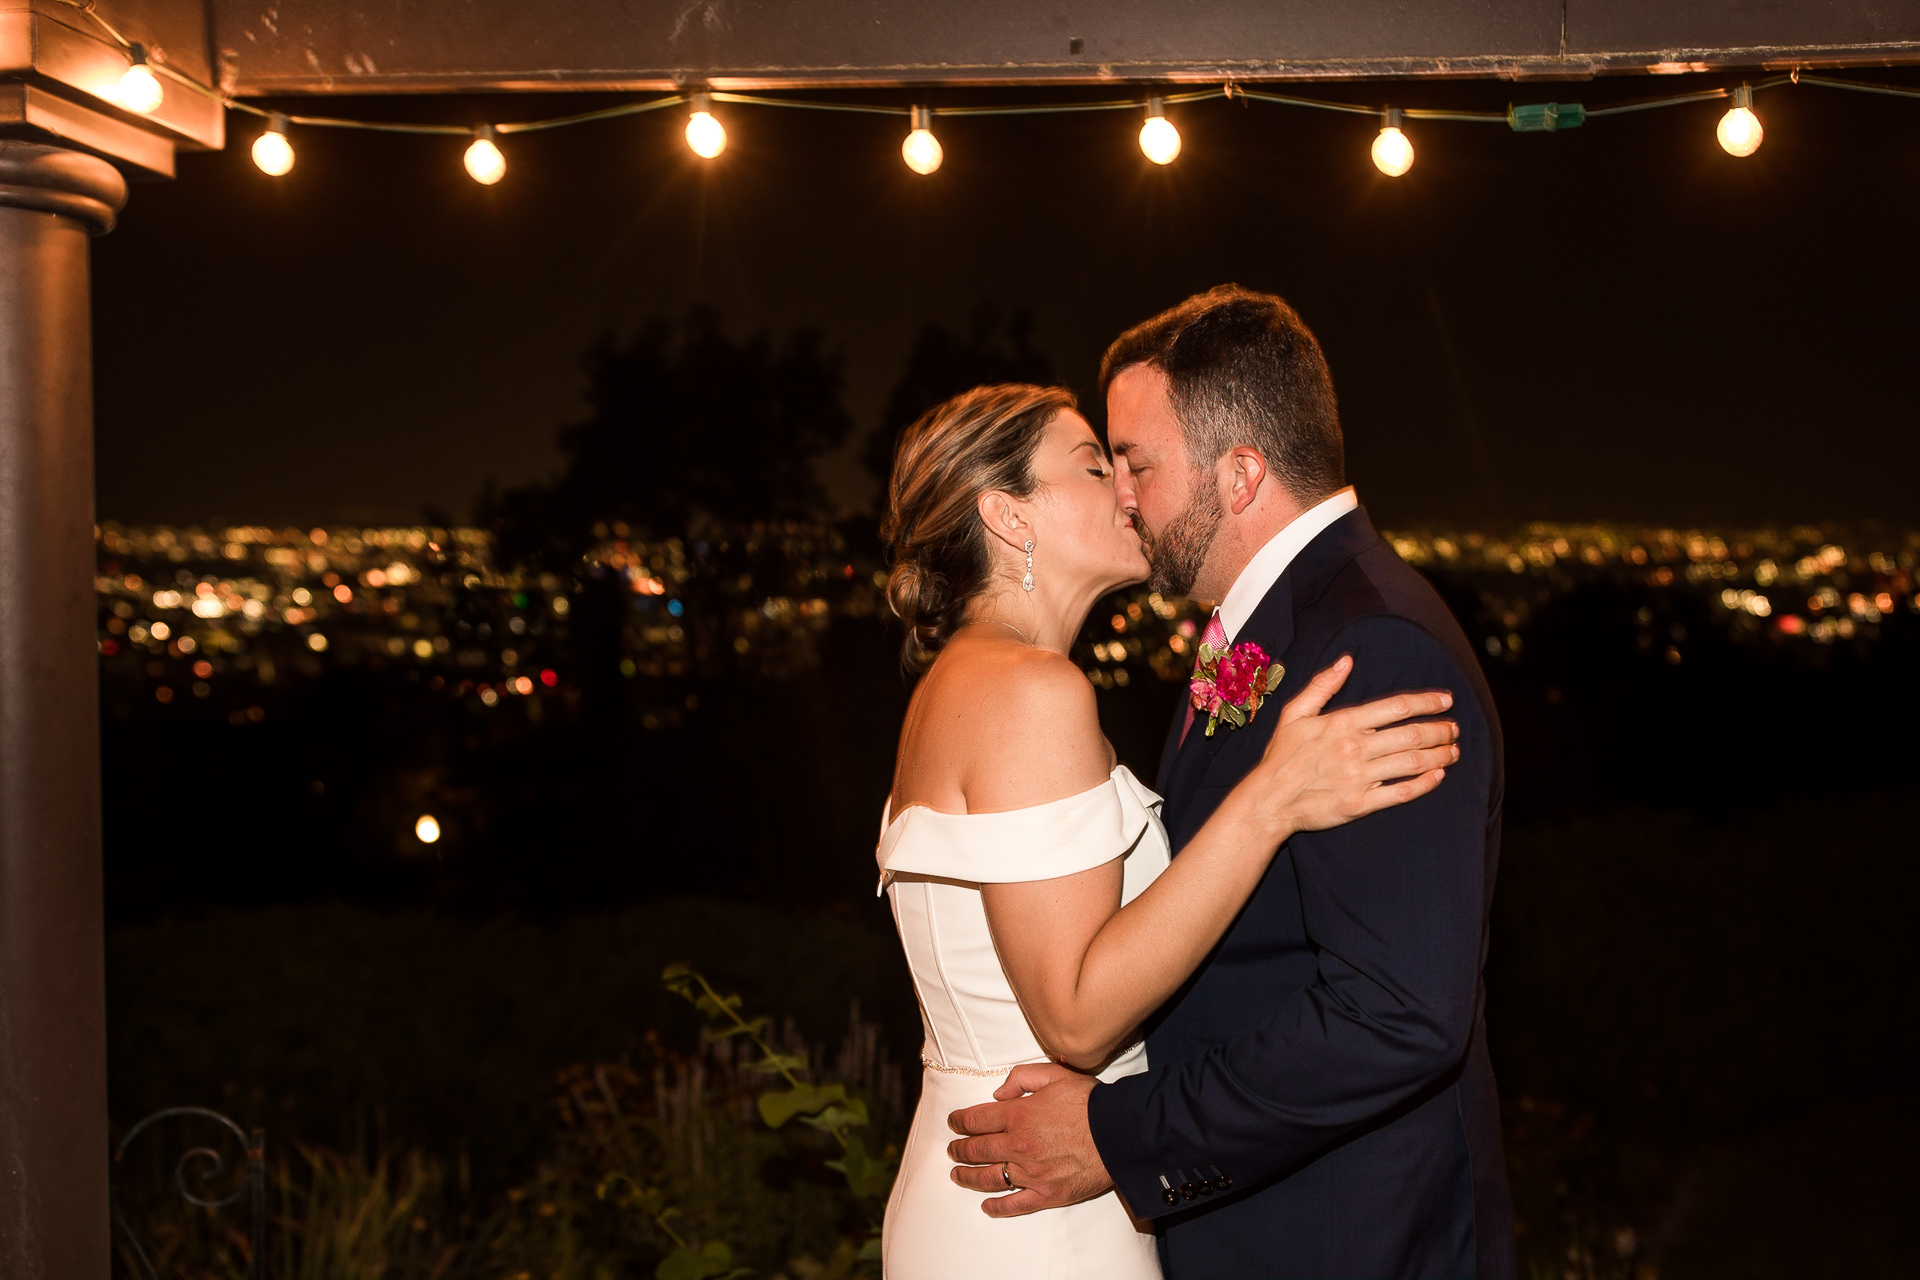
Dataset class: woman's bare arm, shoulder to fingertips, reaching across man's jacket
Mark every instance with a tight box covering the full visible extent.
[966,658,1459,1069]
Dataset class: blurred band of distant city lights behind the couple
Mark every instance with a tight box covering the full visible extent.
[96,524,1920,729]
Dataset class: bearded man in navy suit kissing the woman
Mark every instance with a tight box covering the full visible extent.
[950,286,1517,1280]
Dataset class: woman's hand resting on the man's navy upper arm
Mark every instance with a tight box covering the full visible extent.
[1236,656,1459,842]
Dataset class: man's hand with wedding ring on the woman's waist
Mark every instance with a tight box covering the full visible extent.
[947,1063,1114,1219]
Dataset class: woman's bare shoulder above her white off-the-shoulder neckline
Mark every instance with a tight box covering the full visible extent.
[920,645,1114,812]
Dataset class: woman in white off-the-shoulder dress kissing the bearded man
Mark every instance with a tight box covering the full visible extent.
[877,386,1459,1280]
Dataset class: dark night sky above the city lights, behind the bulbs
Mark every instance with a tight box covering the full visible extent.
[94,69,1920,528]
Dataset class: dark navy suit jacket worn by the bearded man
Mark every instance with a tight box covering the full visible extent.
[1089,510,1517,1280]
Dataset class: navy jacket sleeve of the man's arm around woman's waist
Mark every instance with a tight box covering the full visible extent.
[1089,616,1494,1217]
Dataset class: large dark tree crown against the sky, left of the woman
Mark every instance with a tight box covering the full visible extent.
[480,309,851,568]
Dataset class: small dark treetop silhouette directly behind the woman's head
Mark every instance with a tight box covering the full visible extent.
[860,301,1054,505]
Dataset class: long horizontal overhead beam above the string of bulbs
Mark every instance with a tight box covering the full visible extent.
[209,0,1920,96]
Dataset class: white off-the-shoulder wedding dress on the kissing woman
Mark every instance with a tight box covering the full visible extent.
[877,766,1167,1280]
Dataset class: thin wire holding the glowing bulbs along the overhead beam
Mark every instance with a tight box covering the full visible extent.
[37,0,1920,167]
